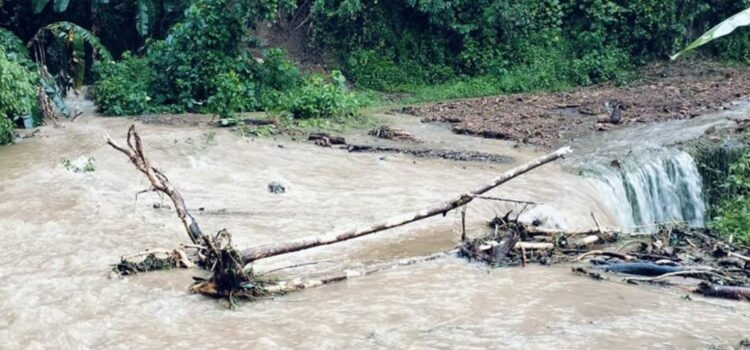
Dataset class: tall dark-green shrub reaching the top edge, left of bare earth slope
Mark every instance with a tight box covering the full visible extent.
[147,0,290,110]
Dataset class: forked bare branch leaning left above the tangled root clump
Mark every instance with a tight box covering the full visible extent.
[106,125,203,243]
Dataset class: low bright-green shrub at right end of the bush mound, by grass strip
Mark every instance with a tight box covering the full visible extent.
[281,71,361,119]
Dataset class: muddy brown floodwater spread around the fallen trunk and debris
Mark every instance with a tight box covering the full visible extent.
[0,111,750,349]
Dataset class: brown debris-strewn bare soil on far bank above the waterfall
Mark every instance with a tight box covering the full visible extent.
[402,61,750,147]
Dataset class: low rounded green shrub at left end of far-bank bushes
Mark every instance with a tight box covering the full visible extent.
[94,52,155,115]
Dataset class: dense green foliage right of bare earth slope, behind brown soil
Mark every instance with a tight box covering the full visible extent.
[312,0,750,93]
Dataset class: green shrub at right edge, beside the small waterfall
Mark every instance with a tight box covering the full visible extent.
[709,151,750,244]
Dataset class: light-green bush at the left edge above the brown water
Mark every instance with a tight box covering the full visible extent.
[0,48,37,144]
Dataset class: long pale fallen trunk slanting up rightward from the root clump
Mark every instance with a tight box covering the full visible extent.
[242,147,572,262]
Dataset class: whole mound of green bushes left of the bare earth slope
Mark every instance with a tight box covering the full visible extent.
[95,0,362,118]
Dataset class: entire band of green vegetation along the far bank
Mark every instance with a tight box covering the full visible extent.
[0,0,750,138]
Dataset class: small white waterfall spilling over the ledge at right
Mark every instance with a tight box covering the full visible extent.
[582,148,706,231]
